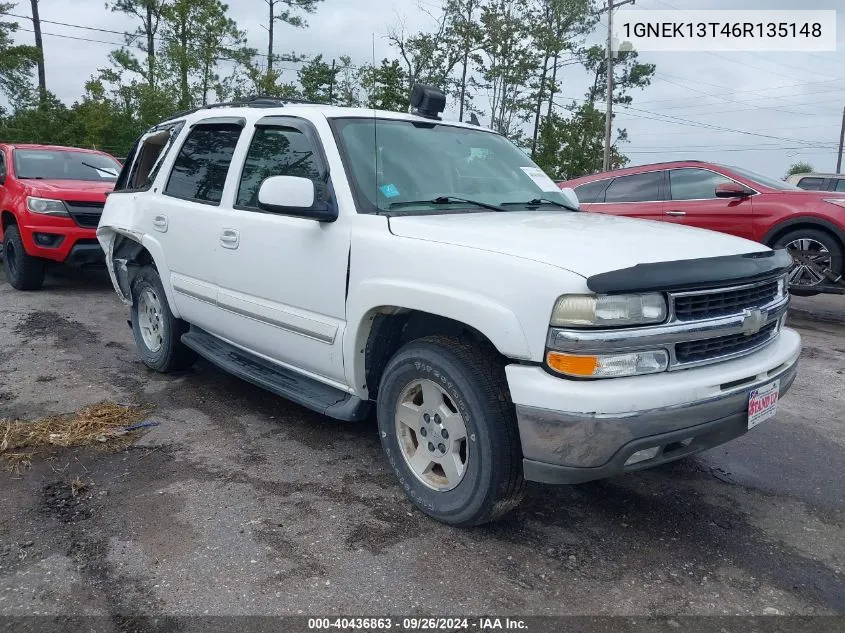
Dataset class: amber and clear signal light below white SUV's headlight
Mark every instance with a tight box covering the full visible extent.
[546,349,669,378]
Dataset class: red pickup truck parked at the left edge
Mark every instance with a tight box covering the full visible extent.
[0,143,121,290]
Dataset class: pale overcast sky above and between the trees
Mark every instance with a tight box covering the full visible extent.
[4,0,845,177]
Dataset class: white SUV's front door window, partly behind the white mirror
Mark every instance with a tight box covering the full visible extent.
[235,127,326,209]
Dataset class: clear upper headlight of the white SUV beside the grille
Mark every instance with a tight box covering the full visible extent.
[552,293,666,327]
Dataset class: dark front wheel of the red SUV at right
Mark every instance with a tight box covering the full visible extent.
[773,229,842,297]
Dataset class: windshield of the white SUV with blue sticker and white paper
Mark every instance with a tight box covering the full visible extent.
[333,118,572,215]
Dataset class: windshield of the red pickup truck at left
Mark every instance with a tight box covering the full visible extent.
[14,149,120,182]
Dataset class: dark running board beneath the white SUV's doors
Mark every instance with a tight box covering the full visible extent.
[182,326,370,421]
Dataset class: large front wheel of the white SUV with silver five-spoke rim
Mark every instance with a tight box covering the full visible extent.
[377,336,524,527]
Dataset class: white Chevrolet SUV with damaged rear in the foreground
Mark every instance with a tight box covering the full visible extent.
[97,87,801,525]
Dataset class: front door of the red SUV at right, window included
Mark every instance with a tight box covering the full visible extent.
[665,167,756,239]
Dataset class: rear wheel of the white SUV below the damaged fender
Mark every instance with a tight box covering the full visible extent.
[131,266,197,373]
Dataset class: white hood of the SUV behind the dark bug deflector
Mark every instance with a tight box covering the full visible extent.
[390,211,769,277]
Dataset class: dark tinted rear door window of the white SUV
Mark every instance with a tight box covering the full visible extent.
[164,125,241,204]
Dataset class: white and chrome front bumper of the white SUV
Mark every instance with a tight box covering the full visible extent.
[506,328,801,484]
